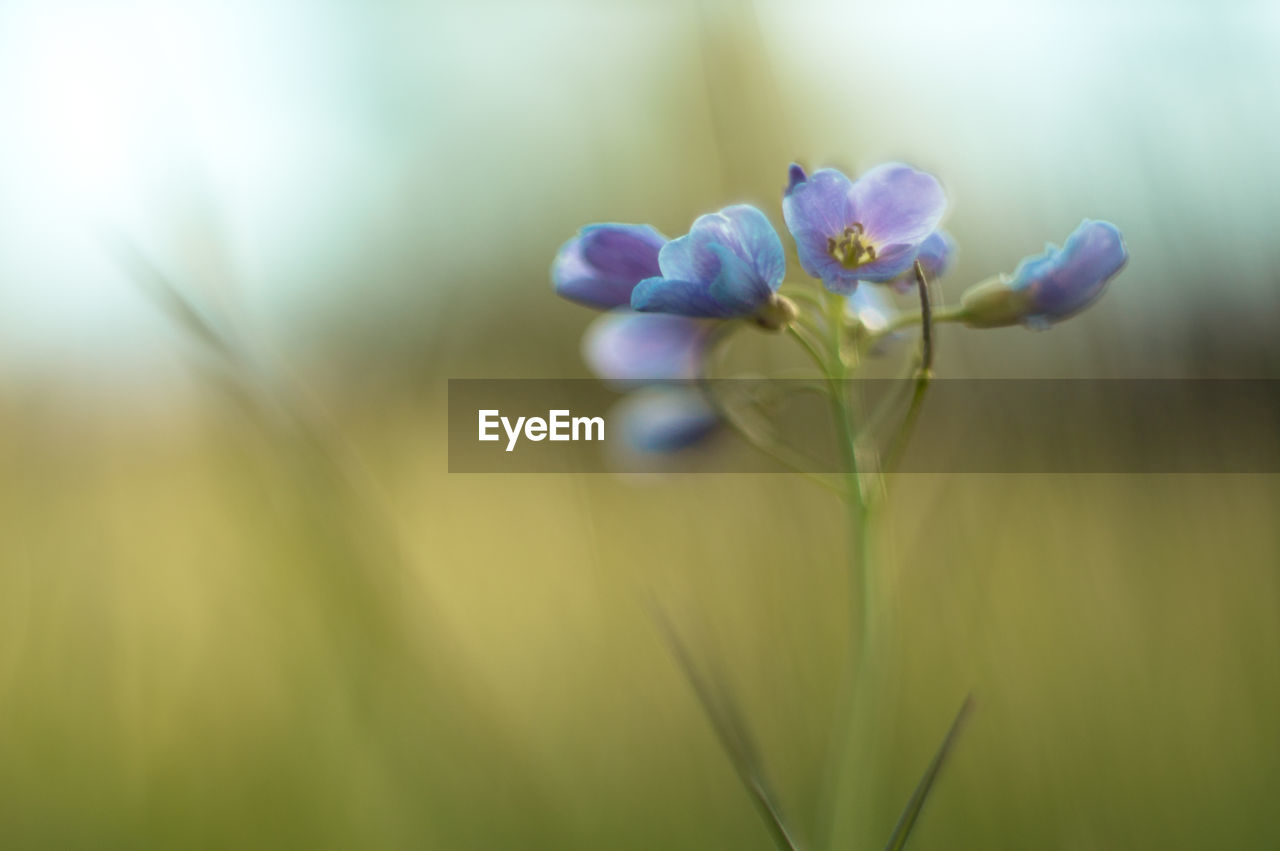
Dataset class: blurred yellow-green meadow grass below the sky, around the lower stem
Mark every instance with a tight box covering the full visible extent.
[0,386,1280,848]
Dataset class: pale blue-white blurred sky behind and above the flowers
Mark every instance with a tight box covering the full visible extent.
[0,0,1280,378]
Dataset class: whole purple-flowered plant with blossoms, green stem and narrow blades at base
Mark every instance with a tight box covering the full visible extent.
[552,156,1129,851]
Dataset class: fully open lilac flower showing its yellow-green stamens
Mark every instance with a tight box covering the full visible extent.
[782,163,947,296]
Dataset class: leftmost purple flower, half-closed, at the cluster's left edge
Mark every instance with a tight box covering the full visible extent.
[552,224,667,310]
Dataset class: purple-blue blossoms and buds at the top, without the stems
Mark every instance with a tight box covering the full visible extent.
[552,163,1128,450]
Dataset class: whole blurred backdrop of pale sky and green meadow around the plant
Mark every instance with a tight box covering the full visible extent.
[0,0,1280,850]
